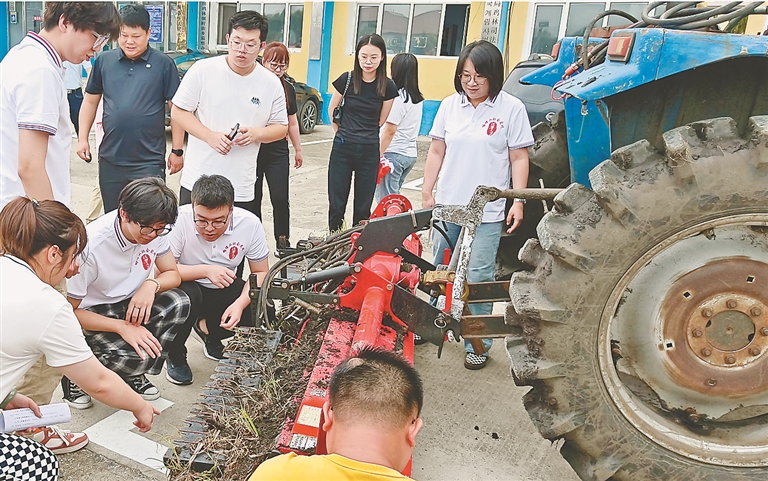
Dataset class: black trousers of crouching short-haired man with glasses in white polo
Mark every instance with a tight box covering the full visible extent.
[168,277,254,363]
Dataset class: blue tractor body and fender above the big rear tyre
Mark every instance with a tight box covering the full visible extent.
[521,28,768,186]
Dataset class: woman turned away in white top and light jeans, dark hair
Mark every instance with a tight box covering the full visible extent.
[375,53,424,204]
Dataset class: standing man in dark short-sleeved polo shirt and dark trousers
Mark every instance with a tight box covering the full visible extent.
[77,5,184,212]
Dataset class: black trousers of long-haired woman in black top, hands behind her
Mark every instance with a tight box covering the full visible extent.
[328,135,379,232]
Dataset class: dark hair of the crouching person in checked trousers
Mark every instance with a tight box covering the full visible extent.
[117,177,179,225]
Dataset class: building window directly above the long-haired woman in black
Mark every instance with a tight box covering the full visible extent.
[356,3,469,57]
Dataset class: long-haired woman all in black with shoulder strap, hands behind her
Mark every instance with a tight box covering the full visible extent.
[328,33,398,232]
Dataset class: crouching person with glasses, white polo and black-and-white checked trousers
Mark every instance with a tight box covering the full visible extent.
[62,177,190,409]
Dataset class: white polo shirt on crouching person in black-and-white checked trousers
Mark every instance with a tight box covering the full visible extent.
[67,210,171,309]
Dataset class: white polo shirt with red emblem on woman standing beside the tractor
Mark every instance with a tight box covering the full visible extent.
[429,91,533,222]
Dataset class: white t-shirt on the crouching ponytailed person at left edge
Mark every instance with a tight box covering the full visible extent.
[0,256,93,399]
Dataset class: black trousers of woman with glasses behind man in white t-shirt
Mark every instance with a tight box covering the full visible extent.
[253,139,291,241]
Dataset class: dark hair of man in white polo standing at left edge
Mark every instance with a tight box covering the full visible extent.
[43,2,120,40]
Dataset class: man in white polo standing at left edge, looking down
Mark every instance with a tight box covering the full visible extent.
[0,2,120,208]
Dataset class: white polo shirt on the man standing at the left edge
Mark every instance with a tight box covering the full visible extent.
[0,32,72,208]
